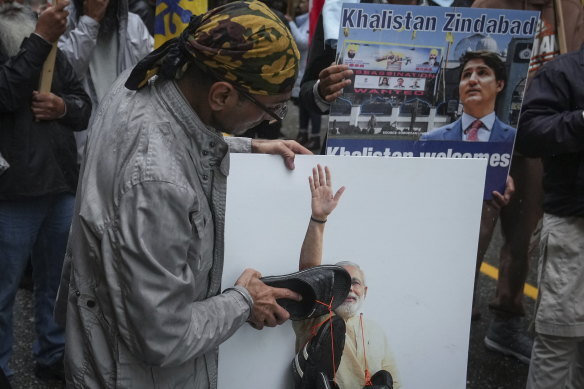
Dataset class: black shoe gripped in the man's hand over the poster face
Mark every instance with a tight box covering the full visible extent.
[261,265,351,320]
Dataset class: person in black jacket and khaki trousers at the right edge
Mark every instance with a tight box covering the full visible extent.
[516,45,584,389]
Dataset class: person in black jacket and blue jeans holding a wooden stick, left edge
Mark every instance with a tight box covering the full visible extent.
[0,0,91,378]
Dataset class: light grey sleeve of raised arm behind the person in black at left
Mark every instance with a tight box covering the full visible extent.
[59,15,99,79]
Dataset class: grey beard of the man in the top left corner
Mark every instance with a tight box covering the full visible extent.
[0,2,36,57]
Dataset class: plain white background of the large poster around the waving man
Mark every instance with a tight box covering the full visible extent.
[218,154,486,389]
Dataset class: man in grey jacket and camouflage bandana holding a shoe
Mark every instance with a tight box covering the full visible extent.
[56,2,309,389]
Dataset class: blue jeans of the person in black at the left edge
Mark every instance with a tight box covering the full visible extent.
[0,193,75,376]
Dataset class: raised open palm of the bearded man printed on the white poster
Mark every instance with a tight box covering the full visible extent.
[308,165,345,220]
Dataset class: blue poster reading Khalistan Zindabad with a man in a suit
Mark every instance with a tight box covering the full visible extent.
[326,4,539,199]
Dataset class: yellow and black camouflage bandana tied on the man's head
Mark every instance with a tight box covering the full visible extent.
[126,1,299,95]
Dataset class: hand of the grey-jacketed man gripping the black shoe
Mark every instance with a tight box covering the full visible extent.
[235,269,302,330]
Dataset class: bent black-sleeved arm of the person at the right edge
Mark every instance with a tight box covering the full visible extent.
[515,61,584,157]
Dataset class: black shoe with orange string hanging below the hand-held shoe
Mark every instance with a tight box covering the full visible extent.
[292,316,346,389]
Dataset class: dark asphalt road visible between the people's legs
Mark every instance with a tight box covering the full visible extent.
[6,105,537,389]
